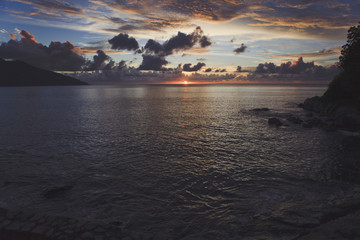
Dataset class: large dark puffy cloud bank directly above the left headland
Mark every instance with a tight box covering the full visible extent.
[0,30,86,71]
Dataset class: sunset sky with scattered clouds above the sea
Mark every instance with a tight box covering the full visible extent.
[0,0,360,83]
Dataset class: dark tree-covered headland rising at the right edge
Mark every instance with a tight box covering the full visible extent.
[301,24,360,132]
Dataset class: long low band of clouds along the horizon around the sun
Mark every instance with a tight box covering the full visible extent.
[67,57,340,83]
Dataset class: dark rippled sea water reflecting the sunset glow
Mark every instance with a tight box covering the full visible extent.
[0,85,360,239]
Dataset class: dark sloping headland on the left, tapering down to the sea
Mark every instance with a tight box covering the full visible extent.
[0,59,88,87]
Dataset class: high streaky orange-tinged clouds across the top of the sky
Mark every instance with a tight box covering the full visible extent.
[4,0,360,39]
